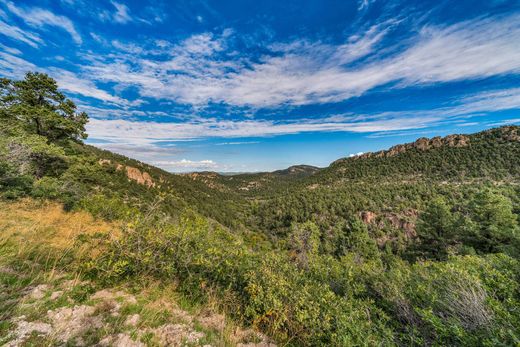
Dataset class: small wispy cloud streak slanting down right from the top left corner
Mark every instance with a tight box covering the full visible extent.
[6,2,83,44]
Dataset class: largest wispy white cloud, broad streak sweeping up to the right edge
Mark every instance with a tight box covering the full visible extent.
[76,14,520,108]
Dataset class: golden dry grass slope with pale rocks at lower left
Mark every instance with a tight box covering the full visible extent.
[0,199,272,346]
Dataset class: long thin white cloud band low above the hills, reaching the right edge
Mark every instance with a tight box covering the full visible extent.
[87,84,520,146]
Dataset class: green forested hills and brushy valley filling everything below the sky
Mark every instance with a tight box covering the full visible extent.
[0,73,520,346]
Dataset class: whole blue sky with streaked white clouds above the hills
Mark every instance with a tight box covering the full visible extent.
[0,0,520,172]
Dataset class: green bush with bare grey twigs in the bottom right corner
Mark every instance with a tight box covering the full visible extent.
[373,255,520,346]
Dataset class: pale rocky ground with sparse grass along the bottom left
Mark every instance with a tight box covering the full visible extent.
[0,268,275,347]
